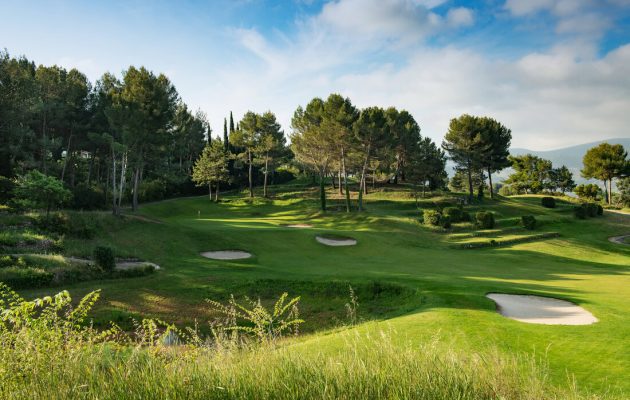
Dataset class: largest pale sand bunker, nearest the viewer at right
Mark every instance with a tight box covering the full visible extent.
[486,293,597,325]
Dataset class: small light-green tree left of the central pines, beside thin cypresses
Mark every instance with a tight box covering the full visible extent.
[192,139,230,201]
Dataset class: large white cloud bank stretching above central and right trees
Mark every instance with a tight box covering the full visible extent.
[186,0,630,149]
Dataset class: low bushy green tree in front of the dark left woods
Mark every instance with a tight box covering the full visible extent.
[14,170,72,218]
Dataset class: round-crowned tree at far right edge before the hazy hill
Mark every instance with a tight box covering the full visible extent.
[582,143,630,204]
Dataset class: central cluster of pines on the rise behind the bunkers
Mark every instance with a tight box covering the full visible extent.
[291,94,447,211]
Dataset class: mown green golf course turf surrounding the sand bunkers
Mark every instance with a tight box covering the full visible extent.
[18,185,630,392]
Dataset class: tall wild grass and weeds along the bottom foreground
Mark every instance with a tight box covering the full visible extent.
[0,284,612,400]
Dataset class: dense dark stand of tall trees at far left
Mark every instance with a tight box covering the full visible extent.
[0,51,211,212]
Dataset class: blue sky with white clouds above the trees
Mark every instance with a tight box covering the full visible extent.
[0,0,630,150]
